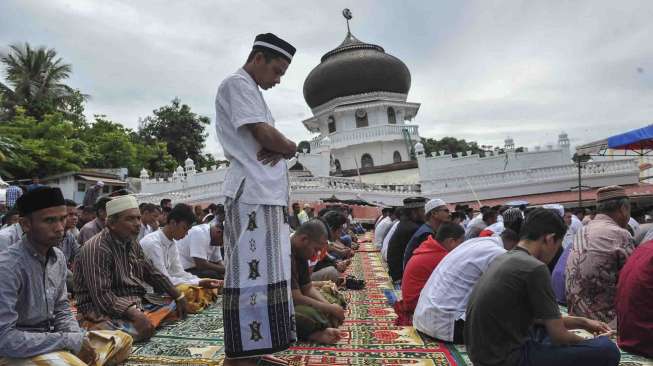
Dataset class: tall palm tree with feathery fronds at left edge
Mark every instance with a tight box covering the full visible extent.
[0,43,86,120]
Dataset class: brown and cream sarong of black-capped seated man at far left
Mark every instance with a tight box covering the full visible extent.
[0,330,132,366]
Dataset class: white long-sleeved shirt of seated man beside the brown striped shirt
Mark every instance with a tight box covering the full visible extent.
[140,230,200,286]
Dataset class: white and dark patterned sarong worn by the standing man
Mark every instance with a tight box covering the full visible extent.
[223,188,296,358]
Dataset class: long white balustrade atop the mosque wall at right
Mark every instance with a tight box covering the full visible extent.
[421,160,639,193]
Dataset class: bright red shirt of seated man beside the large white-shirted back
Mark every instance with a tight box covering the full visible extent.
[395,235,447,325]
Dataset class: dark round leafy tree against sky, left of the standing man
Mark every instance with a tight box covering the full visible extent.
[138,98,216,168]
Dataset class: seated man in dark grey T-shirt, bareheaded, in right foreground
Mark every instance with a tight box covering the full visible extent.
[463,208,620,366]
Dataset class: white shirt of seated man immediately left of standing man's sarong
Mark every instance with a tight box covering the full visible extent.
[177,224,222,269]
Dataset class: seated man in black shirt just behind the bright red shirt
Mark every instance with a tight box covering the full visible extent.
[388,197,426,284]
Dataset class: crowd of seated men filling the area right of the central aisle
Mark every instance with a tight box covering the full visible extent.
[374,186,653,365]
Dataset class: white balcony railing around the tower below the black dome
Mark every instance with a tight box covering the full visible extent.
[311,125,419,152]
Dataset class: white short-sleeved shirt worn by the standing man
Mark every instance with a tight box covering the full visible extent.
[215,68,288,206]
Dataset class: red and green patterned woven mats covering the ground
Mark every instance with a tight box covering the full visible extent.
[127,233,653,366]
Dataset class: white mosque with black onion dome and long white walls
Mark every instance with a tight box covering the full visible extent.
[140,11,640,210]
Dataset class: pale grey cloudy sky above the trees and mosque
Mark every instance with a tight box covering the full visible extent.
[0,0,653,155]
